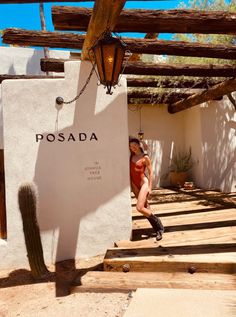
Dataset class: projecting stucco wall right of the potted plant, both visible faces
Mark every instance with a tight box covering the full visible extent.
[185,94,236,192]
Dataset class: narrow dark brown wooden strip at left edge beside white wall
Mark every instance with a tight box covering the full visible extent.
[0,149,7,239]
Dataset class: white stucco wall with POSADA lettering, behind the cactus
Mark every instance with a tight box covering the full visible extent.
[0,62,131,268]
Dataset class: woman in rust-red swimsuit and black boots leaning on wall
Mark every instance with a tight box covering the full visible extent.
[129,138,164,240]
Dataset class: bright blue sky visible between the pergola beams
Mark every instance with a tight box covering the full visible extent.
[0,0,188,45]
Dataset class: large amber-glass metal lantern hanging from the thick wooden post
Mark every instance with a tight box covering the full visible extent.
[90,31,125,95]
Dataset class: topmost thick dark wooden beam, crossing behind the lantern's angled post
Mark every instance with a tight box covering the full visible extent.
[52,6,236,34]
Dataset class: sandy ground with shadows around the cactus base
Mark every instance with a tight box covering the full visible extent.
[0,258,132,317]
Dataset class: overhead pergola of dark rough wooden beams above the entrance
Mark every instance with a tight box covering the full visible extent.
[0,0,236,114]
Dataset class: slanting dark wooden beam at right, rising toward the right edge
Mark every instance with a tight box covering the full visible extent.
[168,78,236,113]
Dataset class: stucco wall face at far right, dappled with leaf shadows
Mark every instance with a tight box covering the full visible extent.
[201,99,236,192]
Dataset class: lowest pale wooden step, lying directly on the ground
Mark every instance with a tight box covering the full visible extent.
[72,271,236,293]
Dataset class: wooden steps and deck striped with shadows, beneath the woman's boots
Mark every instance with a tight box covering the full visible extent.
[73,189,236,291]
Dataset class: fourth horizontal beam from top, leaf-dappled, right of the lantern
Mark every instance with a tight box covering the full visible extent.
[127,77,220,89]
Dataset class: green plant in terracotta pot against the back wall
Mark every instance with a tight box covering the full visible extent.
[169,148,194,187]
